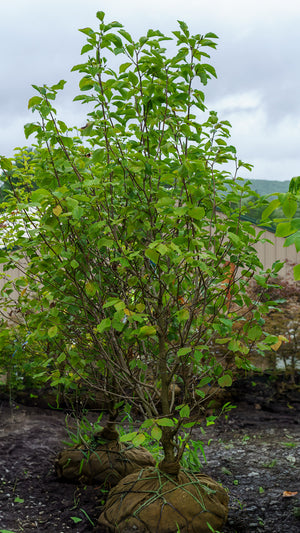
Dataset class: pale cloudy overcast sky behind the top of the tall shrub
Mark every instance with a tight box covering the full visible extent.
[0,0,300,180]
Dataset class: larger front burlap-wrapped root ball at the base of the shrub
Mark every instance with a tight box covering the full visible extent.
[98,467,229,533]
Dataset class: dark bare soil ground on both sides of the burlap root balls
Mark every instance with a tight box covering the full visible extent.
[0,376,300,533]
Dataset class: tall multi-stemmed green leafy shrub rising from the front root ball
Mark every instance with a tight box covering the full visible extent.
[0,12,281,461]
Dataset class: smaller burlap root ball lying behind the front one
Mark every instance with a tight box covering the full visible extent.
[54,440,155,488]
